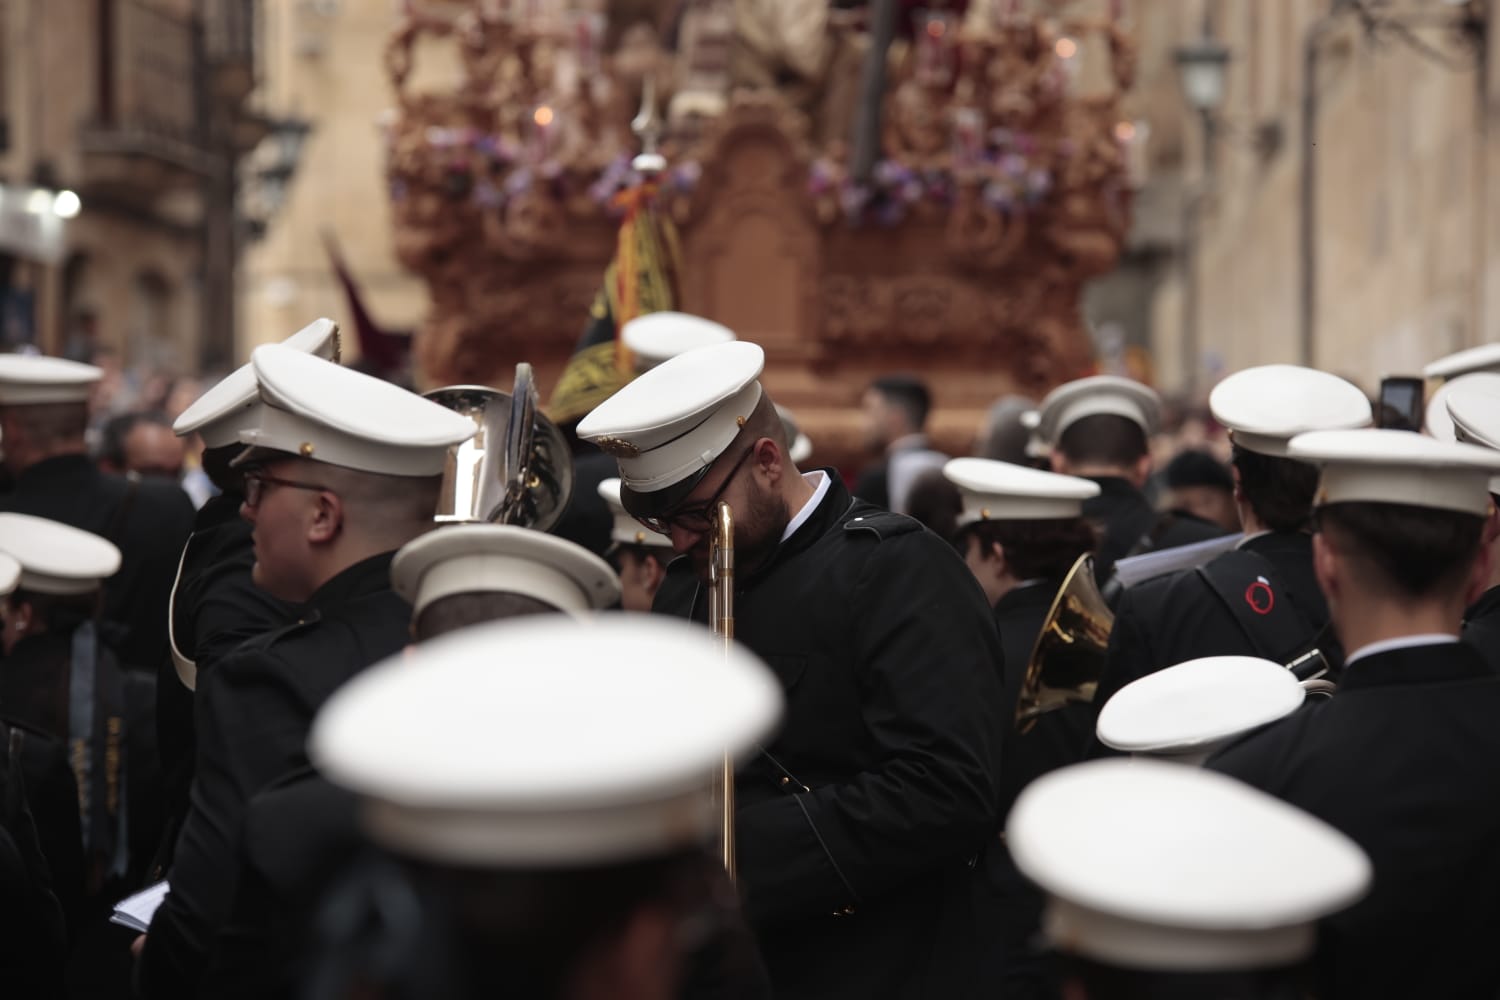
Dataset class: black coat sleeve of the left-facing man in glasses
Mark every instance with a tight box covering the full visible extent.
[140,649,312,1000]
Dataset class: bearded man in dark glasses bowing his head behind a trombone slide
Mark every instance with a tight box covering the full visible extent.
[579,342,1016,997]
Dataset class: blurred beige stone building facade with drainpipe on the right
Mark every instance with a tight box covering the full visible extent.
[1116,0,1500,396]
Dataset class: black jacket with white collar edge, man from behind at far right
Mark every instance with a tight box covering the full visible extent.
[1208,643,1500,1000]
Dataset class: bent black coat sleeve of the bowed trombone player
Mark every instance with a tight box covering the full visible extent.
[738,532,1008,922]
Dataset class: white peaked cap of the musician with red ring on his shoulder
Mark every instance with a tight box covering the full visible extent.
[1209,364,1373,459]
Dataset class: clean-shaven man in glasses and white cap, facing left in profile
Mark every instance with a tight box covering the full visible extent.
[140,345,474,997]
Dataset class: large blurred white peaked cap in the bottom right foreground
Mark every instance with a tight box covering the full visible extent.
[1007,760,1371,972]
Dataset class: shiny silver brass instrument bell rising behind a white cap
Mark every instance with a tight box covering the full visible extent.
[426,363,573,531]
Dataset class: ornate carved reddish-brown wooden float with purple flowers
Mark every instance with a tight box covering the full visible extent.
[387,0,1134,468]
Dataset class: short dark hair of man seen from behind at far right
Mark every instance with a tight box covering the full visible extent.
[1316,502,1485,598]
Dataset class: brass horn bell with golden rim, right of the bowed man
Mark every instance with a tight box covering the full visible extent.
[1016,553,1115,733]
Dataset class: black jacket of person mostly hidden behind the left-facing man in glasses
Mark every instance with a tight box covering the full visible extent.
[156,493,296,861]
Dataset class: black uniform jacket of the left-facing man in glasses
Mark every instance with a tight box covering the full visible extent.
[140,553,411,997]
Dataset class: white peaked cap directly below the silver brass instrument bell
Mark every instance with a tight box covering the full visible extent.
[390,525,620,618]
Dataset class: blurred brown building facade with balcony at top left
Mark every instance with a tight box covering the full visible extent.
[0,0,261,372]
